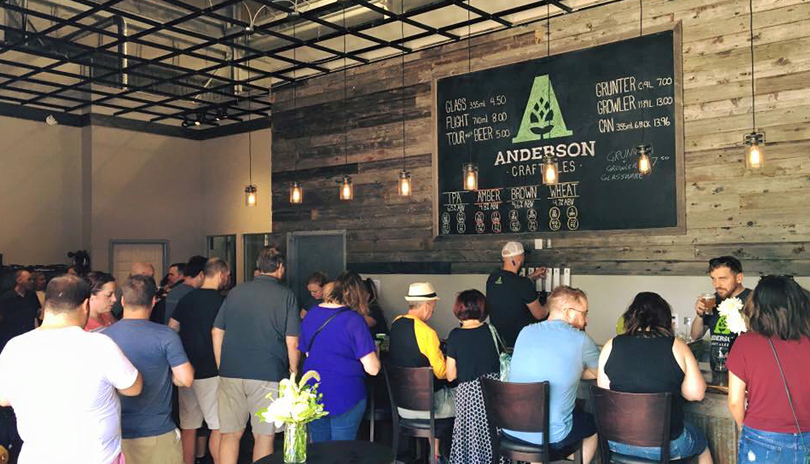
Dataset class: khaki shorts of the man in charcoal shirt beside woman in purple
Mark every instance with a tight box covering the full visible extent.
[217,377,281,435]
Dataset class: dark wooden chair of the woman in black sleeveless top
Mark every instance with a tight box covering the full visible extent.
[591,385,681,464]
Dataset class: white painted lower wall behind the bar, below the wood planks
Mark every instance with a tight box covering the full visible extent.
[364,272,810,344]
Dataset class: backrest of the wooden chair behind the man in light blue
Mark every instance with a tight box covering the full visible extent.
[481,378,549,432]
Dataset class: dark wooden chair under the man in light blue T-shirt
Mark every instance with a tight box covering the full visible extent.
[481,378,582,464]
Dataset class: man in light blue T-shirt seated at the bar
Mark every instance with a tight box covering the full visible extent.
[504,285,599,464]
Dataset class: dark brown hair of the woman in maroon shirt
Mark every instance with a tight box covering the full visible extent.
[743,276,810,340]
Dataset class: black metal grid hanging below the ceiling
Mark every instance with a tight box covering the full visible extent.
[0,0,572,127]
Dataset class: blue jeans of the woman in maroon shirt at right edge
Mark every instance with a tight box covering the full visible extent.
[737,426,810,464]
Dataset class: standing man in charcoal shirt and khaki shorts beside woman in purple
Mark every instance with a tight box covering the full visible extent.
[211,247,301,464]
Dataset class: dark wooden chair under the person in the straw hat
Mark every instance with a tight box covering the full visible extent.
[383,364,453,464]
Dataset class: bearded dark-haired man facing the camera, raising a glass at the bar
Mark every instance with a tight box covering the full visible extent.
[690,256,751,372]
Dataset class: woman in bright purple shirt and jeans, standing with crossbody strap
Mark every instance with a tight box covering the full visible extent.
[298,271,380,442]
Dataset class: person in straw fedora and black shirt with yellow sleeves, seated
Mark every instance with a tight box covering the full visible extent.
[389,282,456,420]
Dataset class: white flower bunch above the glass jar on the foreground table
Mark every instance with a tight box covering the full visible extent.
[256,371,329,427]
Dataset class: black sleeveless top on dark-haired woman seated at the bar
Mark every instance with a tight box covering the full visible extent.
[605,335,685,440]
